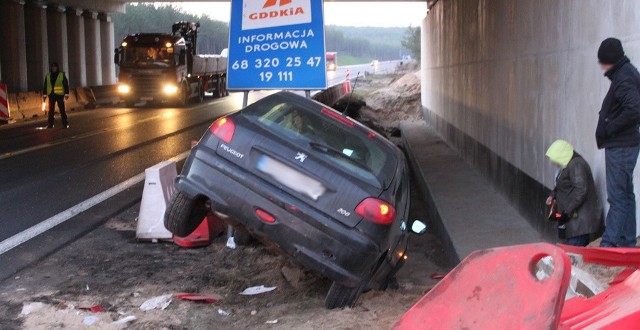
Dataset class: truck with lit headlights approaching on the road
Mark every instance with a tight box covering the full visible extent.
[114,21,229,107]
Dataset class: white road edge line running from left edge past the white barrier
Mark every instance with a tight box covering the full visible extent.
[0,151,191,255]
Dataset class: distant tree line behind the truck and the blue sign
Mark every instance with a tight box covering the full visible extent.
[112,3,410,60]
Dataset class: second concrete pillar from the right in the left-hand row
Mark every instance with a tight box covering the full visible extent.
[83,11,102,86]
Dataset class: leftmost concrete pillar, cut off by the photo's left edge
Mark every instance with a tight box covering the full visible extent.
[0,0,27,92]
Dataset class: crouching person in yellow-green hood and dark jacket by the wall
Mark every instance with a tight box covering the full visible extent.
[546,140,602,246]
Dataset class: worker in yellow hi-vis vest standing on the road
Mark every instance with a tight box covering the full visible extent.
[42,62,69,128]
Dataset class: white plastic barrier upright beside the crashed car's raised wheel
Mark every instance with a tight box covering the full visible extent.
[136,161,177,240]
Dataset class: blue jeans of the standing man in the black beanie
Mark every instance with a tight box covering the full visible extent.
[600,147,640,247]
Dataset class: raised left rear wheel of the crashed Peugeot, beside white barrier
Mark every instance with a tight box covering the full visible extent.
[164,190,209,237]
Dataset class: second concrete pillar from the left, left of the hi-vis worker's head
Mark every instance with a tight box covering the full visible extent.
[24,3,49,91]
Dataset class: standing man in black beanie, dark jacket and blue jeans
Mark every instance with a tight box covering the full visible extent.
[596,38,640,247]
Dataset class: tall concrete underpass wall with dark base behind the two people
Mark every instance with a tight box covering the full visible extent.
[422,0,640,235]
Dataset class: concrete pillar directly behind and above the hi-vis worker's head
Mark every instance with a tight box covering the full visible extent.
[47,5,69,80]
